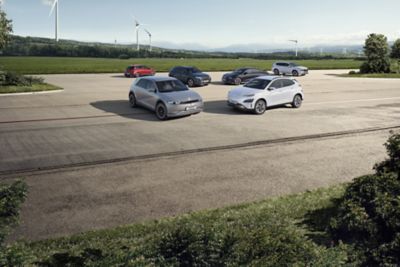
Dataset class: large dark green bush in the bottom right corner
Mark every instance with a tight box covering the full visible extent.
[330,134,400,265]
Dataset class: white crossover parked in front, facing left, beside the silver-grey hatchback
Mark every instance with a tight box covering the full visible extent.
[228,76,304,114]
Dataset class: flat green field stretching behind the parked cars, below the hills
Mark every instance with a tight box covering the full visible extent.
[0,57,361,74]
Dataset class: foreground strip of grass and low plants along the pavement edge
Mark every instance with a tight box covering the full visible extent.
[9,186,351,266]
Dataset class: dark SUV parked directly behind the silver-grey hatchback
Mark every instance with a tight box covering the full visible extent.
[169,66,211,87]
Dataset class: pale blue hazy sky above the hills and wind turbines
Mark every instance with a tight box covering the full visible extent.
[0,0,400,49]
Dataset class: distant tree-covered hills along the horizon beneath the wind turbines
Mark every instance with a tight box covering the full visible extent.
[2,36,361,59]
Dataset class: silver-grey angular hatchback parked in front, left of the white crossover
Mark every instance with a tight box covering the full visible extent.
[129,76,203,120]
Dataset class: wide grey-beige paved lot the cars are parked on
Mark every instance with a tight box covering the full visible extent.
[0,71,400,240]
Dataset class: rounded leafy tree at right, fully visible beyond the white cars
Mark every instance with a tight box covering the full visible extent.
[360,33,390,73]
